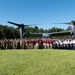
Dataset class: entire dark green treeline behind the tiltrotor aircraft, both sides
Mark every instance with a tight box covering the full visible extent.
[0,25,70,39]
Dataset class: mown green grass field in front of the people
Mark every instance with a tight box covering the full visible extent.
[0,49,75,75]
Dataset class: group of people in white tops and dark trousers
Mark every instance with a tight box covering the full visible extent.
[53,39,75,50]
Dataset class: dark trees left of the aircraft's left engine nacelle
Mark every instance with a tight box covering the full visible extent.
[0,25,20,39]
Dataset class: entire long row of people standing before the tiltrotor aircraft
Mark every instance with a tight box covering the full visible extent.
[0,38,75,49]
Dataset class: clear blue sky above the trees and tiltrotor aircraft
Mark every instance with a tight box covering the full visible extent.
[0,0,75,29]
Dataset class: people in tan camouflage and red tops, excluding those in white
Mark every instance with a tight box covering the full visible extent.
[0,38,54,49]
